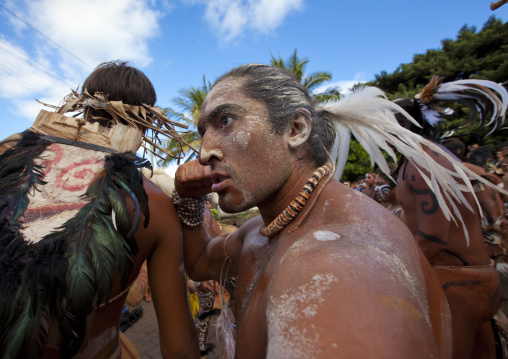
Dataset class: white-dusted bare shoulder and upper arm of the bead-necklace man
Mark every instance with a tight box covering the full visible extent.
[266,184,435,358]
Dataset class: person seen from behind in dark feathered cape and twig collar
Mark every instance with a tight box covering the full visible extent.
[0,61,199,358]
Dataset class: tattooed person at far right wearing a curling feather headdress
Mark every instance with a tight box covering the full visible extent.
[394,76,508,359]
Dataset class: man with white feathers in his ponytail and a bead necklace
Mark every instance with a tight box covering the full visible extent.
[173,64,464,359]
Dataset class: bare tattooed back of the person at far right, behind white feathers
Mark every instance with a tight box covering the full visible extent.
[397,145,501,358]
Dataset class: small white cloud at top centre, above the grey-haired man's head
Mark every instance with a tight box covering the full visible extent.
[189,0,304,42]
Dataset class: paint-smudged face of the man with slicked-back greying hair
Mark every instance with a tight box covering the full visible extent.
[198,79,292,213]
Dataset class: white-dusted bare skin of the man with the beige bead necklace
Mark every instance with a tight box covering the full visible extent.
[175,79,451,359]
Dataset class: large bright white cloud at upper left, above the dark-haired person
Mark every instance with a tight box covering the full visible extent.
[0,0,167,120]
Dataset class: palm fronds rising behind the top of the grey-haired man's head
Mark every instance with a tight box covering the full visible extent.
[270,49,341,102]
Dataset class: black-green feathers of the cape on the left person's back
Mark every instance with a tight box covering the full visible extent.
[0,131,151,358]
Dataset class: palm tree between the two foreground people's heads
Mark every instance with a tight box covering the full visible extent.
[159,75,212,167]
